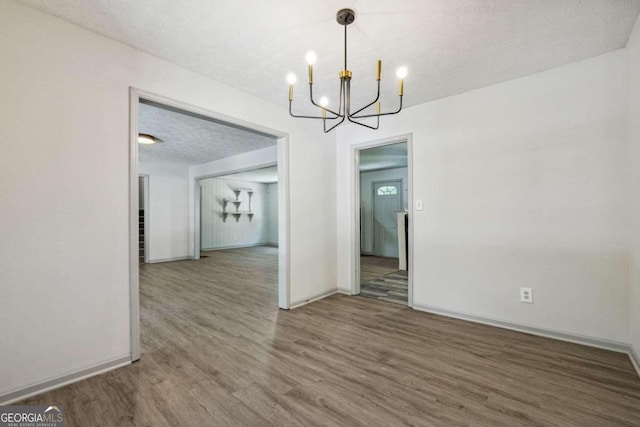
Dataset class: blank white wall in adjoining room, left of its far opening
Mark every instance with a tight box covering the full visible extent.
[138,162,189,262]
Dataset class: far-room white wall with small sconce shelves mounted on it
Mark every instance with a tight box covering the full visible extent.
[200,178,269,250]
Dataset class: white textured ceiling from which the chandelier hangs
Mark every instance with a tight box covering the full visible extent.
[20,0,640,111]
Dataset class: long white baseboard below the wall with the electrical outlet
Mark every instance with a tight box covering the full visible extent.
[413,305,629,353]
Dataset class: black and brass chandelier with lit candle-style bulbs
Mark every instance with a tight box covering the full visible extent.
[287,9,407,133]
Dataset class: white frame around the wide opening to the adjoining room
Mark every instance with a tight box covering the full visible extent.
[129,86,291,362]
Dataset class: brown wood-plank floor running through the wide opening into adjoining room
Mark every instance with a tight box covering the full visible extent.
[20,247,640,426]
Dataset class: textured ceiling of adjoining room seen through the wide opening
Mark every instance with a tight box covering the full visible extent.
[138,104,277,165]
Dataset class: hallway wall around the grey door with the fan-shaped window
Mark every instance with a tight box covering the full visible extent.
[360,168,409,254]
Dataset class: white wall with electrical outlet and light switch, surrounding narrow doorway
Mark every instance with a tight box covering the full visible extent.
[337,50,629,342]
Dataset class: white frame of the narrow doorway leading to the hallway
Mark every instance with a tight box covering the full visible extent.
[350,133,415,308]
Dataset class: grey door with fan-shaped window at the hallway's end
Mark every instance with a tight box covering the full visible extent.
[373,180,402,258]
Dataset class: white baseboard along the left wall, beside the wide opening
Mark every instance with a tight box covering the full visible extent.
[0,354,131,406]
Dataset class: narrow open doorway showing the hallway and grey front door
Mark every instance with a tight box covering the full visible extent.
[358,142,409,305]
